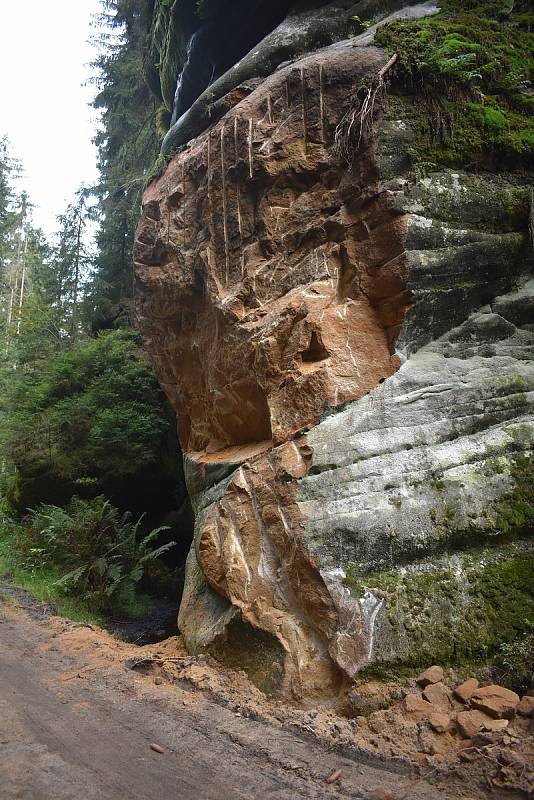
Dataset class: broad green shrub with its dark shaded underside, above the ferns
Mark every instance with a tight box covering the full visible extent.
[0,330,183,514]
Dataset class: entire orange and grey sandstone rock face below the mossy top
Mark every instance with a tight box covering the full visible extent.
[135,3,534,696]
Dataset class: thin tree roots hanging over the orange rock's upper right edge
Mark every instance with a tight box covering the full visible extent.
[334,53,397,167]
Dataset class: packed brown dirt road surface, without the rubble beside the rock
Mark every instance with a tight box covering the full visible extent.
[0,592,443,800]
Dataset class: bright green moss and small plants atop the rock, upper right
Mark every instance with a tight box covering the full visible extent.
[376,0,534,168]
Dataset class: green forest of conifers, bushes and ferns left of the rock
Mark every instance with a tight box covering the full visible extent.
[0,0,191,612]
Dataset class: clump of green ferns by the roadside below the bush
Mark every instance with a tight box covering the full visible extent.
[3,495,174,612]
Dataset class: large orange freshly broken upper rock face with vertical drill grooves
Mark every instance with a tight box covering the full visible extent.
[135,47,411,454]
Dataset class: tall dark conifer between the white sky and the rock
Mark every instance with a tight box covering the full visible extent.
[90,0,160,330]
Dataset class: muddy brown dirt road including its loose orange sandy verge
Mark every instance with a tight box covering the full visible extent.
[0,596,526,800]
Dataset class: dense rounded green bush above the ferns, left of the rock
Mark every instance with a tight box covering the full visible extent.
[0,326,174,507]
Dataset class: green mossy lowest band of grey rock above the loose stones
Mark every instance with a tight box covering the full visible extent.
[346,542,534,675]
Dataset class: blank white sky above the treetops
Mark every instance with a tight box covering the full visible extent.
[0,0,100,234]
